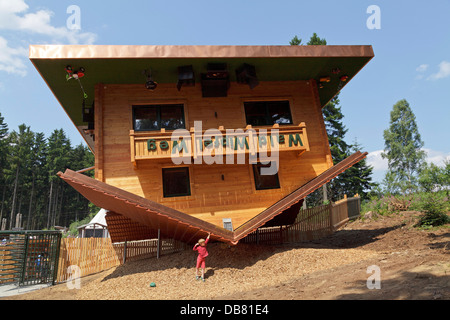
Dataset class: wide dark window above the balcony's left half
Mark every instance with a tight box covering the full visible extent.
[133,104,185,131]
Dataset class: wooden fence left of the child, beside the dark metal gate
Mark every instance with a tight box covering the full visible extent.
[56,238,186,282]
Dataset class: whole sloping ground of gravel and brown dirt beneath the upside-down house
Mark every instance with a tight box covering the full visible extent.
[1,212,450,300]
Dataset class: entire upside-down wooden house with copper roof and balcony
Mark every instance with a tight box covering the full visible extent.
[30,45,374,244]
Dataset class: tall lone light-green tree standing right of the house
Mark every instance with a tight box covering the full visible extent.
[382,99,426,193]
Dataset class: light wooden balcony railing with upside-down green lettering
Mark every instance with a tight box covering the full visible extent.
[130,122,309,164]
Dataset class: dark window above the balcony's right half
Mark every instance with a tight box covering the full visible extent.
[244,100,292,126]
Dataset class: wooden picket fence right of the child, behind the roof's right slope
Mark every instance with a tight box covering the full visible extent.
[242,196,360,245]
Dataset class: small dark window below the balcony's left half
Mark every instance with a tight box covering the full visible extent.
[162,167,191,198]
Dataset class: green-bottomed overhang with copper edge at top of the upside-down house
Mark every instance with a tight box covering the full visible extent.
[29,45,374,149]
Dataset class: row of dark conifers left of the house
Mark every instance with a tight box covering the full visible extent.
[0,113,95,230]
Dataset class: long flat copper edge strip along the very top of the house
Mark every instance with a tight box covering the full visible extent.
[29,45,374,60]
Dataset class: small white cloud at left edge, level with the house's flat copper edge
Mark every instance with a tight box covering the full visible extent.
[0,36,28,76]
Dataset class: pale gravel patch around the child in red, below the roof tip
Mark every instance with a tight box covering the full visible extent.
[77,243,376,300]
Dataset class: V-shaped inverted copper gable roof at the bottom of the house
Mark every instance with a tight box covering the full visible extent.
[58,151,367,245]
